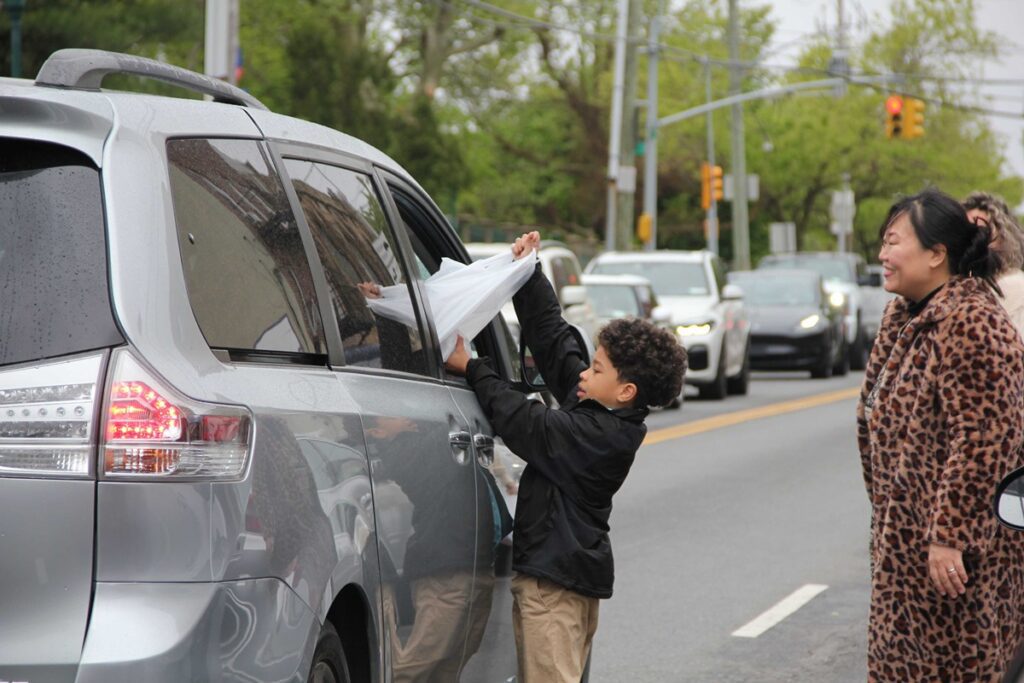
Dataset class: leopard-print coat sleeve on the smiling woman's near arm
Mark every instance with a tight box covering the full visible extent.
[928,308,1024,553]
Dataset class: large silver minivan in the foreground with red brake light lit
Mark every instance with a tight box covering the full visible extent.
[0,50,536,683]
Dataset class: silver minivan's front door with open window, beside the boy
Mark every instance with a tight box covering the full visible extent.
[380,179,516,683]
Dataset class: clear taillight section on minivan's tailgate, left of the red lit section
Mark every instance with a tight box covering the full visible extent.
[0,353,103,477]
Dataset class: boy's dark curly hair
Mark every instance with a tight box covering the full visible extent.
[598,317,686,408]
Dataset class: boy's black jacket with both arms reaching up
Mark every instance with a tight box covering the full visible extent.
[467,267,647,598]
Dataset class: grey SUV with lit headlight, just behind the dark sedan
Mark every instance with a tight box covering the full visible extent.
[758,252,871,370]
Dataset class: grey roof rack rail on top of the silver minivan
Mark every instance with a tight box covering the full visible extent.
[36,49,267,110]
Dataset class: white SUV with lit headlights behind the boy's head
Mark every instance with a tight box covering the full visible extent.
[587,250,751,398]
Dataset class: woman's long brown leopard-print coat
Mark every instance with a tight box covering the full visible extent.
[857,278,1024,683]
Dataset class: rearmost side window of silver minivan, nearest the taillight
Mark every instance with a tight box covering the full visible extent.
[167,139,327,361]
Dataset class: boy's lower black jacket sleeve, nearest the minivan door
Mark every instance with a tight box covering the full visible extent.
[466,358,592,493]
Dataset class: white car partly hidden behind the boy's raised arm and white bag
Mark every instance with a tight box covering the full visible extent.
[466,240,600,344]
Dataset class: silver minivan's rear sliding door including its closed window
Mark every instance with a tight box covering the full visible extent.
[283,150,477,682]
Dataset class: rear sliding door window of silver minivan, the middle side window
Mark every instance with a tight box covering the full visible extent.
[285,159,429,375]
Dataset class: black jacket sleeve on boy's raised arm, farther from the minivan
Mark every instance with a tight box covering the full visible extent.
[512,263,589,403]
